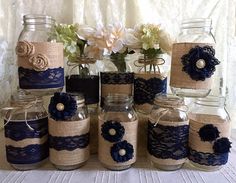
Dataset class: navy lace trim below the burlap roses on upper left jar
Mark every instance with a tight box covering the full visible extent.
[18,67,64,89]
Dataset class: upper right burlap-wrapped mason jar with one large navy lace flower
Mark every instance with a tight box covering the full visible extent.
[170,19,220,97]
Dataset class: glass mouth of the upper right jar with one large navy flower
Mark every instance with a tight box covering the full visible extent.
[181,18,212,29]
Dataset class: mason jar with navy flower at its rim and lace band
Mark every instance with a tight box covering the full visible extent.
[48,92,90,170]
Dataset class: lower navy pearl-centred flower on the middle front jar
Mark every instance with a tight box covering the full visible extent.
[110,140,134,163]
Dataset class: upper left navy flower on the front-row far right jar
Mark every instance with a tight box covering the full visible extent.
[198,124,220,141]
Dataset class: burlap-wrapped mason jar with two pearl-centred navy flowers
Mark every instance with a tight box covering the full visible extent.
[98,94,138,170]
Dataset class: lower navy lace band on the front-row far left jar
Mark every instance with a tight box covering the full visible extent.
[6,142,49,164]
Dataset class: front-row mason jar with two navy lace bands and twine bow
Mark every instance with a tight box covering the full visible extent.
[4,91,48,170]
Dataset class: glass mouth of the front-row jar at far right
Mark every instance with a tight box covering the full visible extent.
[195,95,225,107]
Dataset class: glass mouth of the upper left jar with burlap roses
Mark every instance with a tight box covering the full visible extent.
[23,14,55,25]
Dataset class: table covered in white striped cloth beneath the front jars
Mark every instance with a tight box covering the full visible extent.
[0,131,236,183]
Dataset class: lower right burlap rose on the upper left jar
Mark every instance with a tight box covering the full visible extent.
[29,53,48,71]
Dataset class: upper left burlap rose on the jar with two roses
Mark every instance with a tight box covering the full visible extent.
[16,41,35,57]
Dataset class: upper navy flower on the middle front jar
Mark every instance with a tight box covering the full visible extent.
[101,120,125,142]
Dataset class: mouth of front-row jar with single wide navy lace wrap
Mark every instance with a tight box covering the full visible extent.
[154,94,184,108]
